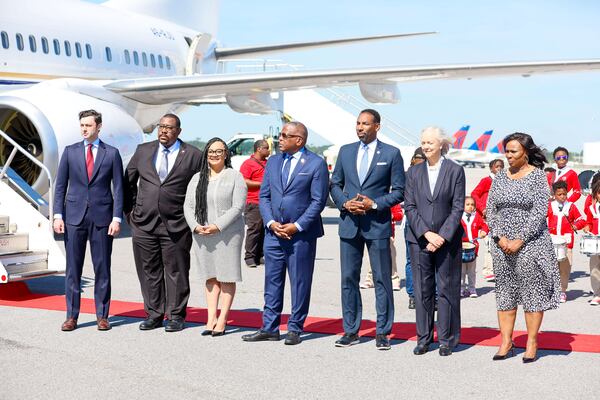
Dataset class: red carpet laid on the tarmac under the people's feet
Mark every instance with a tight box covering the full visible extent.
[0,282,600,353]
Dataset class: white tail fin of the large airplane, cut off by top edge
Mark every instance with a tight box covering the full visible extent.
[101,0,220,37]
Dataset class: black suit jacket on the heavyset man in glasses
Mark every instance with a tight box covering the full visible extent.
[124,140,202,233]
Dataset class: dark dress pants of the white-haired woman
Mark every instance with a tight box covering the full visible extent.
[410,242,462,348]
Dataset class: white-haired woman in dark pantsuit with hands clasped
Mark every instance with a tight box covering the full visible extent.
[404,127,465,356]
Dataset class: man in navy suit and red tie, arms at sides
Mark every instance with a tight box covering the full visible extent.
[54,110,123,331]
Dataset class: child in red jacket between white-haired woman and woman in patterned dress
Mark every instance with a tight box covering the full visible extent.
[460,196,490,298]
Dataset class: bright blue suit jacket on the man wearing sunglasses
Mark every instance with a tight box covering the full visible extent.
[259,148,329,239]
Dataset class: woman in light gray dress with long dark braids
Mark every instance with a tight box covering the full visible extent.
[184,138,248,336]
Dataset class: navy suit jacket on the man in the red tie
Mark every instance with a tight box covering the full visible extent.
[54,140,123,226]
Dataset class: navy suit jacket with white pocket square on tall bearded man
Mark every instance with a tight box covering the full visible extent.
[331,141,404,239]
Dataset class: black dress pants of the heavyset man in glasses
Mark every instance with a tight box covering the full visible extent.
[131,221,192,319]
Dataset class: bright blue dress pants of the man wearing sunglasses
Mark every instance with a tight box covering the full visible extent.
[262,231,317,333]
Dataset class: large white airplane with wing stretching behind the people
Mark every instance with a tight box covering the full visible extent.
[0,0,600,193]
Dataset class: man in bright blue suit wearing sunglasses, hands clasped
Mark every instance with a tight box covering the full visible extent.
[242,122,329,345]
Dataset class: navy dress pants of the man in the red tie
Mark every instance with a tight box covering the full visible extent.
[65,208,113,319]
